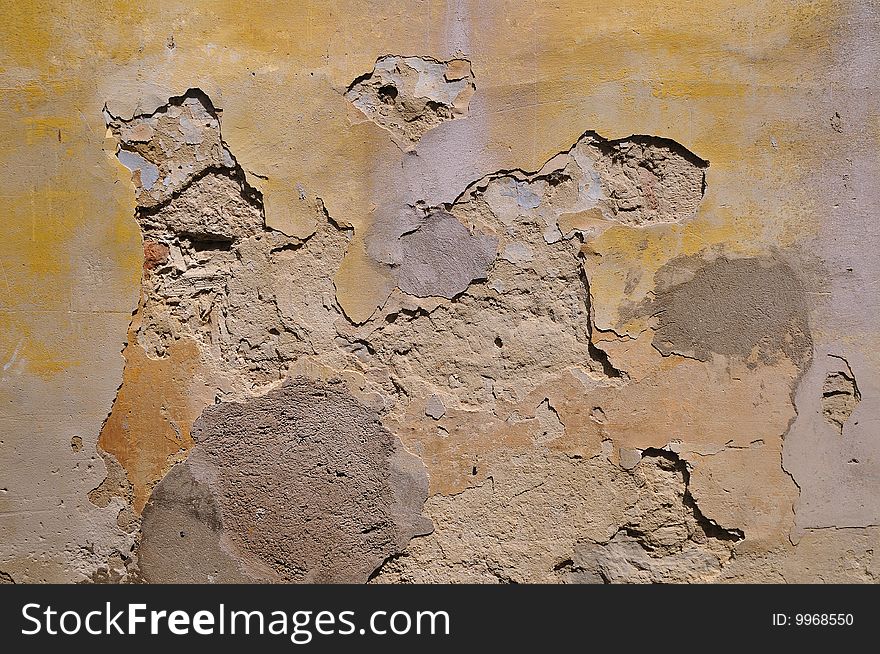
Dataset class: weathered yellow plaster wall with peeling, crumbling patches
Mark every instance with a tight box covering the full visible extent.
[0,0,880,583]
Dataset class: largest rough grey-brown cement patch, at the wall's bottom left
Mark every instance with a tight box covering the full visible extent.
[141,378,433,583]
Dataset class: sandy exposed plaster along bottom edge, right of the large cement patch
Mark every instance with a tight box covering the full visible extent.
[373,449,742,583]
